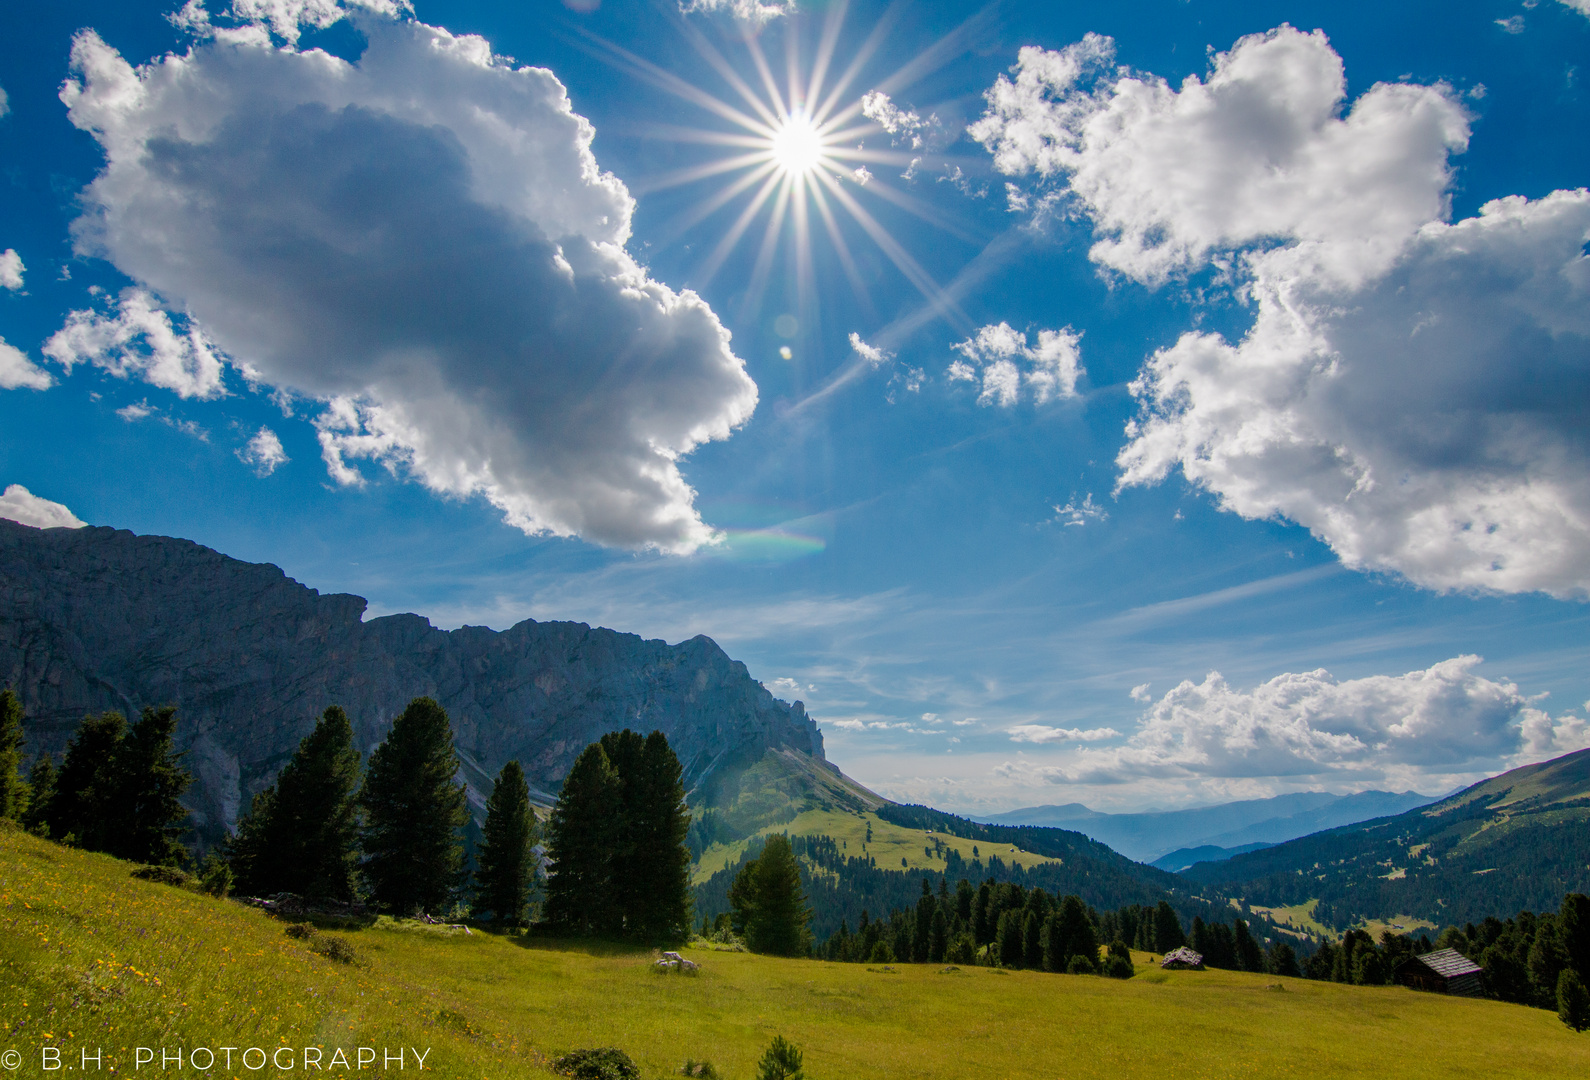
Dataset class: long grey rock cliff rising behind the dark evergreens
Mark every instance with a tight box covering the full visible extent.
[0,520,838,838]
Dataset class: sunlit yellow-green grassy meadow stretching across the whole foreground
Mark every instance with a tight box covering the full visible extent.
[0,826,1590,1080]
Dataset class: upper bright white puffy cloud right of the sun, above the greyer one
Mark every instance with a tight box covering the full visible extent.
[971,25,1469,282]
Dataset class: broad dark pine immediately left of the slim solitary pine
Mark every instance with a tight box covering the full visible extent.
[359,698,469,915]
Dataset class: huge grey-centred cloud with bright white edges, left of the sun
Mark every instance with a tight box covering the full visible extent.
[62,0,757,550]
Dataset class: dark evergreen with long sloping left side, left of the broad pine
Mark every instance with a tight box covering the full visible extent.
[227,705,359,902]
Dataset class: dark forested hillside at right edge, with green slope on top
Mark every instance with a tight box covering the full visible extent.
[1181,751,1590,929]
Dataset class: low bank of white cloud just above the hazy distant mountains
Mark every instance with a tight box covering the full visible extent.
[1006,655,1590,784]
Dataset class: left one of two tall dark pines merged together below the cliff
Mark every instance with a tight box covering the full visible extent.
[545,743,623,934]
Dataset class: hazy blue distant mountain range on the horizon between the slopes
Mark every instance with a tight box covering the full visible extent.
[978,791,1439,868]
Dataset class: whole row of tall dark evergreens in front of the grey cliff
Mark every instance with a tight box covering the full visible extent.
[0,690,690,942]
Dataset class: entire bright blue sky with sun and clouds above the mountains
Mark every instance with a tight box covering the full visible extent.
[0,0,1590,811]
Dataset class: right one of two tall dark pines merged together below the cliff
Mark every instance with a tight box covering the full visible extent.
[625,732,690,942]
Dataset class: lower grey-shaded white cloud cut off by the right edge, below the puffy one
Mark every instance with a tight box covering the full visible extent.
[1118,191,1590,596]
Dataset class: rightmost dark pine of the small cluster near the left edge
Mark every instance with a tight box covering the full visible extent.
[102,705,194,867]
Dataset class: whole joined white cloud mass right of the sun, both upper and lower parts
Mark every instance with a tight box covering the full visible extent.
[973,27,1590,596]
